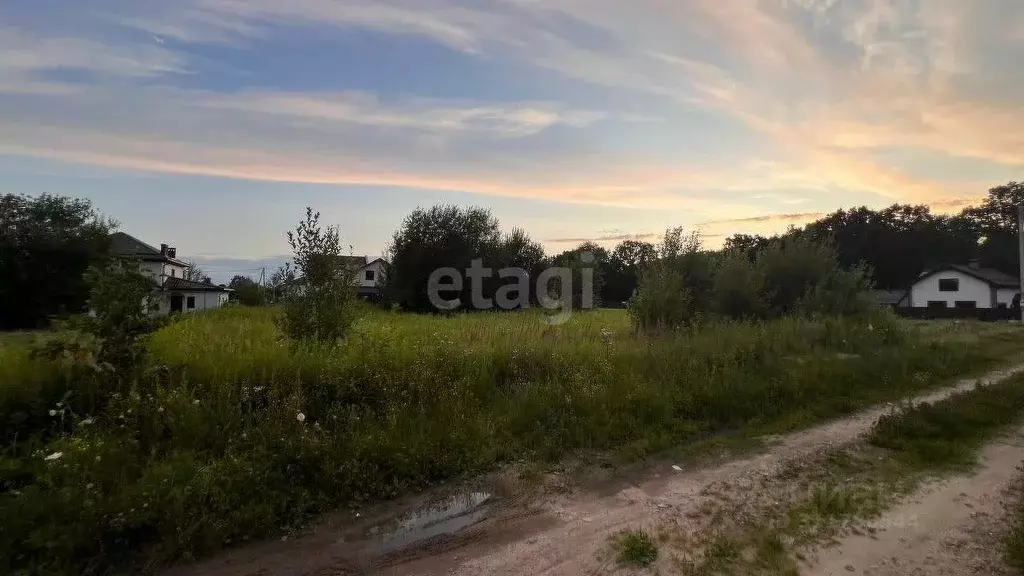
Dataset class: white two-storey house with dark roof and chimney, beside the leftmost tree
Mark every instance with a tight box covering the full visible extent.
[111,232,230,316]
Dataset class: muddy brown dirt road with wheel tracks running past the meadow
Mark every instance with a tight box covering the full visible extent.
[163,365,1024,576]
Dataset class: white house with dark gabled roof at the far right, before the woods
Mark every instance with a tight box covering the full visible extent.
[907,262,1020,308]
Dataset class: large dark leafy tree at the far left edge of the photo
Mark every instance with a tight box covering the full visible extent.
[0,194,116,329]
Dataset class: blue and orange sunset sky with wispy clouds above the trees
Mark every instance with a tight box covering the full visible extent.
[0,0,1024,281]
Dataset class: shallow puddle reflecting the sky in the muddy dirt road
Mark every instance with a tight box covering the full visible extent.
[378,492,490,552]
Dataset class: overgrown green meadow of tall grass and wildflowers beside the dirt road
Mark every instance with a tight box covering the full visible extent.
[0,307,1024,574]
